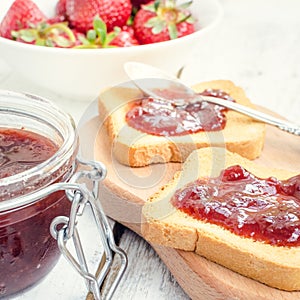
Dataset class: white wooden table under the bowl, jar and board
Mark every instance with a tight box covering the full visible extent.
[0,0,300,300]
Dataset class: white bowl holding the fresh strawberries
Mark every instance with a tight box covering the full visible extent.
[0,0,222,101]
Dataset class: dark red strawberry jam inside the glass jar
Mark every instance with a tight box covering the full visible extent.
[0,128,70,298]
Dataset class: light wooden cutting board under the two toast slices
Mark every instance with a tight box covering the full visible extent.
[80,113,300,300]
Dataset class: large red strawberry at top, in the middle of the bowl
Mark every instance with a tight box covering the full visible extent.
[66,0,132,32]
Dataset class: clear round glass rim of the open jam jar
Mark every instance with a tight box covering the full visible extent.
[0,89,78,211]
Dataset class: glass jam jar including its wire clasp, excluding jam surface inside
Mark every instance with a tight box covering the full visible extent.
[0,90,127,300]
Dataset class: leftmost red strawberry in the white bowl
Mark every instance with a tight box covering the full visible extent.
[0,0,46,39]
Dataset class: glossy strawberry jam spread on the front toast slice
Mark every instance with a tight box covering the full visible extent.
[171,165,300,246]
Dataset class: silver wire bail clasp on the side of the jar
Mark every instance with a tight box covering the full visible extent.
[50,158,127,300]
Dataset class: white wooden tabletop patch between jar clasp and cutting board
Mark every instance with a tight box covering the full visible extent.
[108,229,189,300]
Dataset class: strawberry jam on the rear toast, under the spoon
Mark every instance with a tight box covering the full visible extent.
[126,89,234,136]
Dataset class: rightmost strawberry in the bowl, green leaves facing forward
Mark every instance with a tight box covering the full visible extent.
[133,0,195,44]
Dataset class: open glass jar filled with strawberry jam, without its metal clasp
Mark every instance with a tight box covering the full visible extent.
[0,91,78,298]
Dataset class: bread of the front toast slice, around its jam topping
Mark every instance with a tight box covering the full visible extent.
[141,147,300,291]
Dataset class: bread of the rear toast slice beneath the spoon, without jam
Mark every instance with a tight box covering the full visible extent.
[99,80,265,167]
